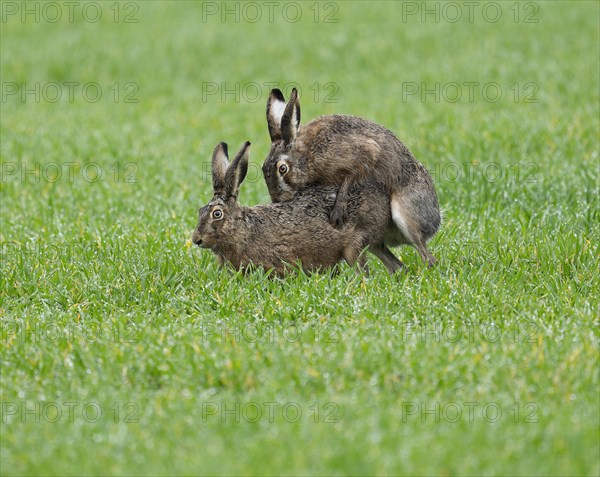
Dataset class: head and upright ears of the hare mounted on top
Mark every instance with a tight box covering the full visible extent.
[263,88,308,202]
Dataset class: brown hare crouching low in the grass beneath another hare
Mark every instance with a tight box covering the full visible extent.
[192,142,401,275]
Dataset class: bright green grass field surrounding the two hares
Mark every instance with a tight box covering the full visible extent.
[0,1,600,476]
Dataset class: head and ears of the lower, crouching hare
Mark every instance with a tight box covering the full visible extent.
[192,142,250,249]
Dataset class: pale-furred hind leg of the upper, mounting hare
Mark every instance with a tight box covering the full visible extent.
[390,192,437,267]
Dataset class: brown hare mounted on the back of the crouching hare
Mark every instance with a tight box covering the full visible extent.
[263,88,441,266]
